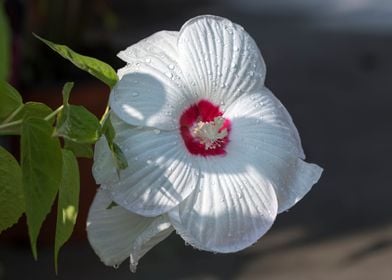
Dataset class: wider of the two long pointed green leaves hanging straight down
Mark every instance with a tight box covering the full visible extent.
[21,118,62,258]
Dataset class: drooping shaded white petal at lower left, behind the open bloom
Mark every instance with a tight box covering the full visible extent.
[87,189,173,270]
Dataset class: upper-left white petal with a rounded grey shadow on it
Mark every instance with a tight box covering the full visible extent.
[110,31,194,129]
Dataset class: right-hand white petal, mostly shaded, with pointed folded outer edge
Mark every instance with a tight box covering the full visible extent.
[225,88,322,213]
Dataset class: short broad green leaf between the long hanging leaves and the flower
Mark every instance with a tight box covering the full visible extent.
[55,105,101,143]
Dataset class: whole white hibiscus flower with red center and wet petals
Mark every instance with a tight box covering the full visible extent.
[87,16,322,270]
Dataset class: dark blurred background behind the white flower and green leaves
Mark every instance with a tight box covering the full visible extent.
[0,0,392,280]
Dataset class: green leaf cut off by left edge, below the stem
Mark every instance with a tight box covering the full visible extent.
[0,146,25,233]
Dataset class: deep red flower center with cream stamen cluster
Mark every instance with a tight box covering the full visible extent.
[180,100,231,156]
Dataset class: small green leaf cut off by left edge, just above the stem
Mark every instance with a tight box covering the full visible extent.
[0,80,23,123]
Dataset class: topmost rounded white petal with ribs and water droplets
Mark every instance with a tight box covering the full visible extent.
[178,16,266,107]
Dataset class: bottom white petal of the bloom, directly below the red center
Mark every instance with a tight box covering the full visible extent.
[169,154,277,253]
